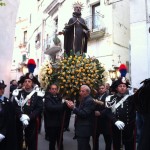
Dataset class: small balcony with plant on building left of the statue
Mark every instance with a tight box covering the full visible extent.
[44,34,61,55]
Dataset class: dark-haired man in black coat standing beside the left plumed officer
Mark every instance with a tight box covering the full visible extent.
[44,84,70,150]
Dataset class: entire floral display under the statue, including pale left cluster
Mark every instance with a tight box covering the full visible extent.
[39,55,106,98]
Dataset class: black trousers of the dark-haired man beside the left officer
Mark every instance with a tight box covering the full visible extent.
[47,127,63,150]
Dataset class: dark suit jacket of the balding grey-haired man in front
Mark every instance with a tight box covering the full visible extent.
[73,96,95,137]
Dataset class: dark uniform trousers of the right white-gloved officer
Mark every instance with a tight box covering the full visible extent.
[112,126,135,150]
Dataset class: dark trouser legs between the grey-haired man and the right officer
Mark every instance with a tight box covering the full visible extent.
[93,133,112,150]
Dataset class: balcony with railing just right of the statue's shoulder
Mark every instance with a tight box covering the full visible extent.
[85,14,106,39]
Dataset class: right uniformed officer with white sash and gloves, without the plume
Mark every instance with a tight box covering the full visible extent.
[106,77,136,150]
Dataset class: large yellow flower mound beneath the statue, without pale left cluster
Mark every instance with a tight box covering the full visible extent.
[58,55,105,97]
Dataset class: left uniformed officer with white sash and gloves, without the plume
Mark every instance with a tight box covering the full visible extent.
[13,73,44,150]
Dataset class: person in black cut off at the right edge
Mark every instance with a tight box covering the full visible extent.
[134,78,150,150]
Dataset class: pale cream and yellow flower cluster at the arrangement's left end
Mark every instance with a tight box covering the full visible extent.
[38,60,53,89]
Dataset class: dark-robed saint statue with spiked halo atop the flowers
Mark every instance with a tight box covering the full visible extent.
[59,2,90,56]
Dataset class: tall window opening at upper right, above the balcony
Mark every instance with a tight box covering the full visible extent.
[92,3,100,29]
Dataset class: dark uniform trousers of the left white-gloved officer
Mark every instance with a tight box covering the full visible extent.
[17,121,38,150]
